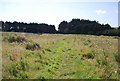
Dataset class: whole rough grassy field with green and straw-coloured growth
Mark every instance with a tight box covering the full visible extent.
[2,32,120,79]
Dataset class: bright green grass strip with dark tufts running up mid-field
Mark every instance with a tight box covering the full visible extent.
[31,38,70,79]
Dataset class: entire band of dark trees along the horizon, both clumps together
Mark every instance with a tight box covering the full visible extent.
[2,19,120,36]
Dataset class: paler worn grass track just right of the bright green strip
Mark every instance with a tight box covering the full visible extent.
[54,38,74,79]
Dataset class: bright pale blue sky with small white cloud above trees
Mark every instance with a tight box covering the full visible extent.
[0,0,118,29]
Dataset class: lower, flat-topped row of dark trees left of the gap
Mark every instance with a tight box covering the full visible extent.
[2,21,56,33]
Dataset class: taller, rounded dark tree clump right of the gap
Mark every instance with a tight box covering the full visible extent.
[58,19,118,36]
